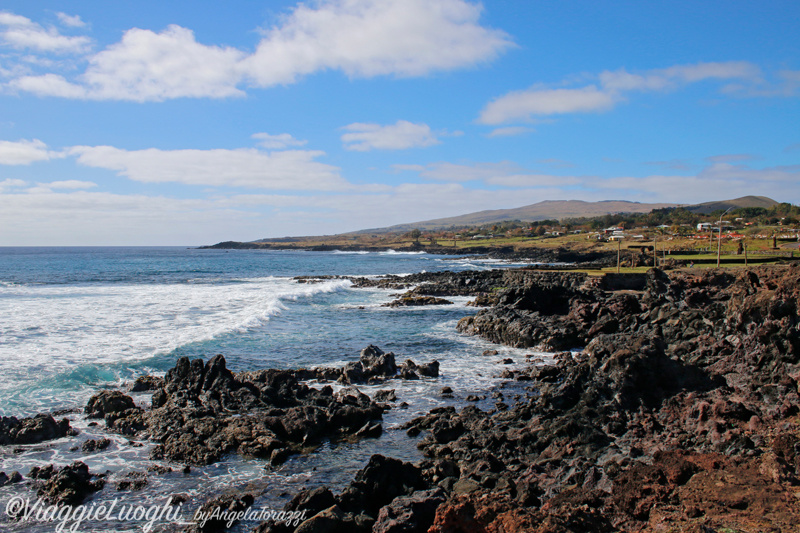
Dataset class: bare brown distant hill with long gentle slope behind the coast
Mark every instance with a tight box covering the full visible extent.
[357,200,678,233]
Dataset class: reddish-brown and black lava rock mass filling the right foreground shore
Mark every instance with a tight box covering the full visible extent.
[260,266,800,533]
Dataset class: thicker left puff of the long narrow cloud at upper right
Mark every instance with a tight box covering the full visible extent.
[478,85,617,125]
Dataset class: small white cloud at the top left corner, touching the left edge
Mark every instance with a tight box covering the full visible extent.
[0,12,92,53]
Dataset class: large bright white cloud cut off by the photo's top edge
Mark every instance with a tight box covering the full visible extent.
[245,0,511,87]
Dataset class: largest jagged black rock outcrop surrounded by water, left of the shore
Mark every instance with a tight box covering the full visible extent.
[87,347,398,465]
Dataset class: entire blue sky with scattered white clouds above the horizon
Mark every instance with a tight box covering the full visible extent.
[0,0,800,246]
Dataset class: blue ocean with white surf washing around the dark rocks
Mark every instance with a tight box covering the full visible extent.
[0,247,544,531]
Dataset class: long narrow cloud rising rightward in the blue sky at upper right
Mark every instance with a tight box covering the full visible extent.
[478,61,761,126]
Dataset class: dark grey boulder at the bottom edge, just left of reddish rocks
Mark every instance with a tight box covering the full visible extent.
[372,488,446,533]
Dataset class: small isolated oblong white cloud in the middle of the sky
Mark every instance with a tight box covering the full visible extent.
[342,120,440,152]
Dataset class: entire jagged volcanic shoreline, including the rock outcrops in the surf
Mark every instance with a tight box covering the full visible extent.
[0,265,800,533]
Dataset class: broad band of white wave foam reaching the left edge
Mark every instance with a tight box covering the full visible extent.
[0,277,351,402]
